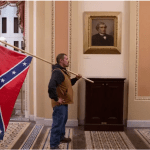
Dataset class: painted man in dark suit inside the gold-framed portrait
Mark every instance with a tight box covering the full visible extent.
[92,22,114,46]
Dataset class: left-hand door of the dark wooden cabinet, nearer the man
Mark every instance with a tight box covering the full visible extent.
[85,82,106,124]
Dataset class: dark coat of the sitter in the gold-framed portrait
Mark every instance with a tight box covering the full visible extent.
[92,33,114,46]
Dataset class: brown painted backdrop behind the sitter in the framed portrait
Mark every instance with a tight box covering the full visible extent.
[91,19,114,37]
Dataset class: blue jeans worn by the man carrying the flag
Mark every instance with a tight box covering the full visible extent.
[50,105,68,147]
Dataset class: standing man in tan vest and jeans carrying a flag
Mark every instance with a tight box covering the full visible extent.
[48,53,81,149]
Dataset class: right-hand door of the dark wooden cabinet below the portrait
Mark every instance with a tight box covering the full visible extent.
[104,82,123,124]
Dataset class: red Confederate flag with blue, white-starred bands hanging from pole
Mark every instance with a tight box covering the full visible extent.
[0,46,32,140]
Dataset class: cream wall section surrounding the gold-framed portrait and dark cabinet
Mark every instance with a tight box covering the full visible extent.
[73,1,130,124]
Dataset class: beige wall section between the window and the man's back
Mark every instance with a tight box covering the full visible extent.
[29,1,52,118]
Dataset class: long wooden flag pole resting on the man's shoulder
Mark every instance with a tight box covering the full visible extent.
[0,40,94,83]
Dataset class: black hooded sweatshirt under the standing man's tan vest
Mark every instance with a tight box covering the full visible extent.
[48,64,78,101]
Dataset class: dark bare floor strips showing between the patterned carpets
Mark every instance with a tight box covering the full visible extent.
[8,120,149,149]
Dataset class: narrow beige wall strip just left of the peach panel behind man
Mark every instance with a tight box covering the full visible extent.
[43,1,52,118]
